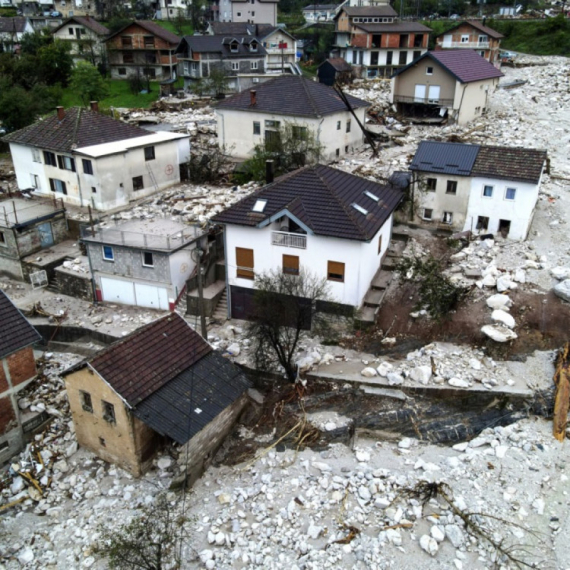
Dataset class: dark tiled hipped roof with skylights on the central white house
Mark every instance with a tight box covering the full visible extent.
[212,165,403,241]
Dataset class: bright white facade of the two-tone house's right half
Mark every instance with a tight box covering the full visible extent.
[463,173,540,235]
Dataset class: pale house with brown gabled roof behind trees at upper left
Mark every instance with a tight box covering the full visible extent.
[52,16,109,65]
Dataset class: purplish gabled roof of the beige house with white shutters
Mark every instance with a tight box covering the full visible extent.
[392,49,504,83]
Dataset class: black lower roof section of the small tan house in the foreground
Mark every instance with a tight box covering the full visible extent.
[133,351,250,445]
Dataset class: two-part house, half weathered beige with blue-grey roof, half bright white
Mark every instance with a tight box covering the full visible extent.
[410,141,547,240]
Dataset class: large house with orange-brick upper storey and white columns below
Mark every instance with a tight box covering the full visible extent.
[334,5,431,78]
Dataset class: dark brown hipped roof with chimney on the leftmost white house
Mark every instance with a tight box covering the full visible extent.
[2,107,149,152]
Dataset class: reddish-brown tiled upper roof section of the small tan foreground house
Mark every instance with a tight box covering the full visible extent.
[84,313,212,407]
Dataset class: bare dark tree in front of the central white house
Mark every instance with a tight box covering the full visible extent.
[247,268,341,382]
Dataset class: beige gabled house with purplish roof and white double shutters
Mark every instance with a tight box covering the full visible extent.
[390,49,503,125]
